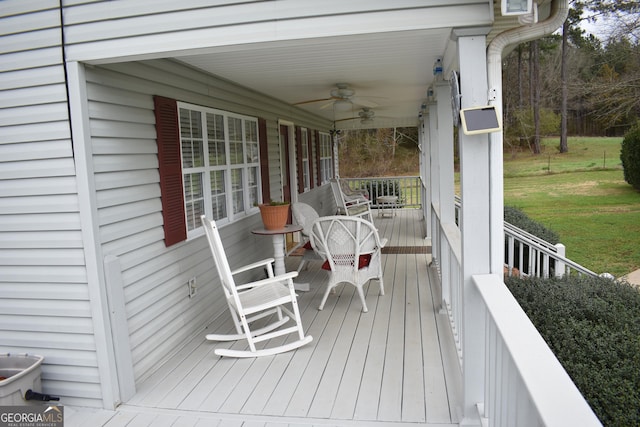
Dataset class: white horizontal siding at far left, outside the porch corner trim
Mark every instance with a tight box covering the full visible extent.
[0,4,102,412]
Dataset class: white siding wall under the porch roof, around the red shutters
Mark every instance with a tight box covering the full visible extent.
[86,60,328,392]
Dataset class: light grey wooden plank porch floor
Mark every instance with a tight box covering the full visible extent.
[65,209,461,427]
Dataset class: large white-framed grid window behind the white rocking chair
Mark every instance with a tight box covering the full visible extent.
[178,102,260,232]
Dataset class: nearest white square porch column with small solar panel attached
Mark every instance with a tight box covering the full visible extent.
[458,34,491,425]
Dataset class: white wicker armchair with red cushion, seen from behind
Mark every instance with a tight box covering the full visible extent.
[310,216,387,313]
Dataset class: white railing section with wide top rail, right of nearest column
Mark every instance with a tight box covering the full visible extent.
[466,275,601,427]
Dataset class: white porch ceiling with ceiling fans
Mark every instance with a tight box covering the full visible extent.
[178,28,451,128]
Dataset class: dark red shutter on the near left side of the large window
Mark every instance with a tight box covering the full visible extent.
[154,96,187,247]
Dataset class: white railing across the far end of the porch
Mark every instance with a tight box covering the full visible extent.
[340,176,422,208]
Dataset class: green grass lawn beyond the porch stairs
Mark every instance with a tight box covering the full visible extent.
[504,138,640,277]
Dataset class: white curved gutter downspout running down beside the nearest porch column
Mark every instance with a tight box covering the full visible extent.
[487,0,569,275]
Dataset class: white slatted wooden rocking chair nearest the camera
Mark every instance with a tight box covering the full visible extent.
[200,215,313,357]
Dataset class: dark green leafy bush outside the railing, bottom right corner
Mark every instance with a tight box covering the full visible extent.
[505,277,640,426]
